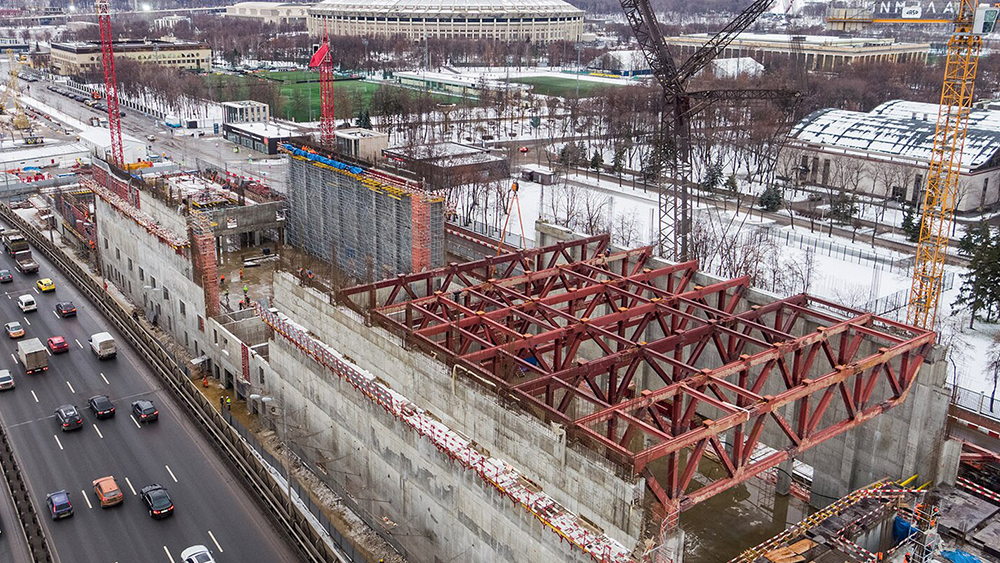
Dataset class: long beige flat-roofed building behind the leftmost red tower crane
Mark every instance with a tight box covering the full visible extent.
[51,39,212,76]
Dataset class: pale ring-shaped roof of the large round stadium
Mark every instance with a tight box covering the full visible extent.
[311,0,584,16]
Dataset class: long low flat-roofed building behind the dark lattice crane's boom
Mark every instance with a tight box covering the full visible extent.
[664,33,931,70]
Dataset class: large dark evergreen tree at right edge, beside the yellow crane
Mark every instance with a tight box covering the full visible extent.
[952,223,1000,328]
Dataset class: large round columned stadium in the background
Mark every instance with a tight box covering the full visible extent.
[309,0,584,43]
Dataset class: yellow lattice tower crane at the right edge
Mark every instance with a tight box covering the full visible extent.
[827,0,1000,329]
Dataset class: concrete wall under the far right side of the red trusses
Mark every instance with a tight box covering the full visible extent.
[535,222,959,506]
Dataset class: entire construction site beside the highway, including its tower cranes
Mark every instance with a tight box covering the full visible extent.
[4,0,1000,563]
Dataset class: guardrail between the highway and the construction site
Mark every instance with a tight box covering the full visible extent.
[0,204,342,563]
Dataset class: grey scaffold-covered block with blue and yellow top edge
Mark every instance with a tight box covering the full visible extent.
[286,145,445,281]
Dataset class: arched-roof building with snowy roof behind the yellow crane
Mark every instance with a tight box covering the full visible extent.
[789,100,1000,212]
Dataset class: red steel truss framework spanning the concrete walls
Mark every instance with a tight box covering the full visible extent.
[340,236,935,514]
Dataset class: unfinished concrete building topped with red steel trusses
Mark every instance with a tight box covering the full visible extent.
[230,223,958,562]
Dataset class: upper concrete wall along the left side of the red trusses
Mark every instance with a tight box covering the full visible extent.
[271,274,646,553]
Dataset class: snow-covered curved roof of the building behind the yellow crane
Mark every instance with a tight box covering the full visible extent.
[791,102,1000,171]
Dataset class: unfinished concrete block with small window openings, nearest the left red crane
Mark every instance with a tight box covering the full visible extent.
[83,159,285,362]
